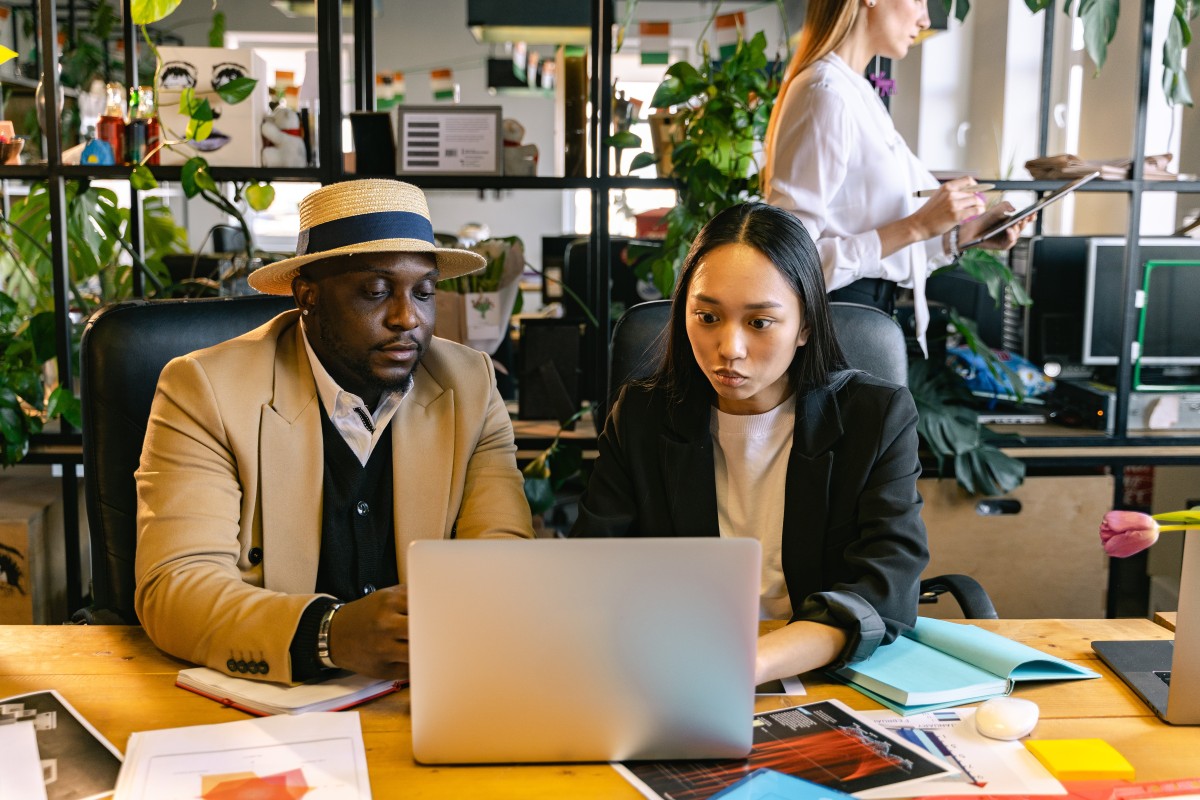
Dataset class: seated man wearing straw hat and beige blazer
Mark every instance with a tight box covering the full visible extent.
[136,180,533,681]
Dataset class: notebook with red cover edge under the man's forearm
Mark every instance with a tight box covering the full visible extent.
[175,667,408,716]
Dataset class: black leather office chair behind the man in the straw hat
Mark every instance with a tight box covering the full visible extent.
[76,295,295,624]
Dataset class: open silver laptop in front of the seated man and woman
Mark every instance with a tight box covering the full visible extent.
[408,537,761,764]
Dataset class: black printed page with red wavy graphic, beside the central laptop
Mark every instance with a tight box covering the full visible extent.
[613,700,956,800]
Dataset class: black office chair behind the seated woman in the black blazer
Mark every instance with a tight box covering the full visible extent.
[608,300,997,619]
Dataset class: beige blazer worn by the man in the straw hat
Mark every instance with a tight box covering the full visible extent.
[134,311,533,680]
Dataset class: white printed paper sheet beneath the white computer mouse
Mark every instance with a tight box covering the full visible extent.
[854,708,1067,800]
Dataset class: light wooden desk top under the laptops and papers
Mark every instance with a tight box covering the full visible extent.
[0,619,1200,800]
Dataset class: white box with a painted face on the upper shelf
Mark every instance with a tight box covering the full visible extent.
[158,47,268,167]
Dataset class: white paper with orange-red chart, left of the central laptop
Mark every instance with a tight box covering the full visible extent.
[113,711,371,800]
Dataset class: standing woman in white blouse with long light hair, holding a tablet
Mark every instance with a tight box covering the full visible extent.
[762,0,1026,343]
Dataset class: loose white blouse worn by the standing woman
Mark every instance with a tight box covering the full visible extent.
[764,53,949,345]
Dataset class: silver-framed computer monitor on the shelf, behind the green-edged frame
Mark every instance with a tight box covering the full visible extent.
[1082,237,1200,367]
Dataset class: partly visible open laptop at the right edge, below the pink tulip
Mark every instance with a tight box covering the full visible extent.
[1092,531,1200,724]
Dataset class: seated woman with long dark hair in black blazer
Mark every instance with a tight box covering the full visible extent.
[571,204,929,682]
